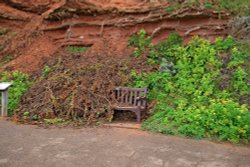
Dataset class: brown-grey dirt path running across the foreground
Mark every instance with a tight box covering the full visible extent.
[0,119,250,167]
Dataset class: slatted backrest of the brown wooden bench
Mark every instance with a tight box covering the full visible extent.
[115,87,147,106]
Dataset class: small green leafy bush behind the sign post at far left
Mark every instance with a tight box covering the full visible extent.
[0,71,32,115]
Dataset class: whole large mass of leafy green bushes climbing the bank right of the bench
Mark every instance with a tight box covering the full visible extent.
[131,34,250,142]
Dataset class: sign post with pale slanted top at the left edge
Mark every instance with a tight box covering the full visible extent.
[0,82,12,117]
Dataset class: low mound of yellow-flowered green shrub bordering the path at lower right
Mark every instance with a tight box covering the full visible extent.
[143,99,250,142]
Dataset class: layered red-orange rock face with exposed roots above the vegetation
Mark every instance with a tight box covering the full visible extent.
[0,0,229,73]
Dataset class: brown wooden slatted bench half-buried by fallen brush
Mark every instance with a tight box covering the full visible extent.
[113,87,147,122]
